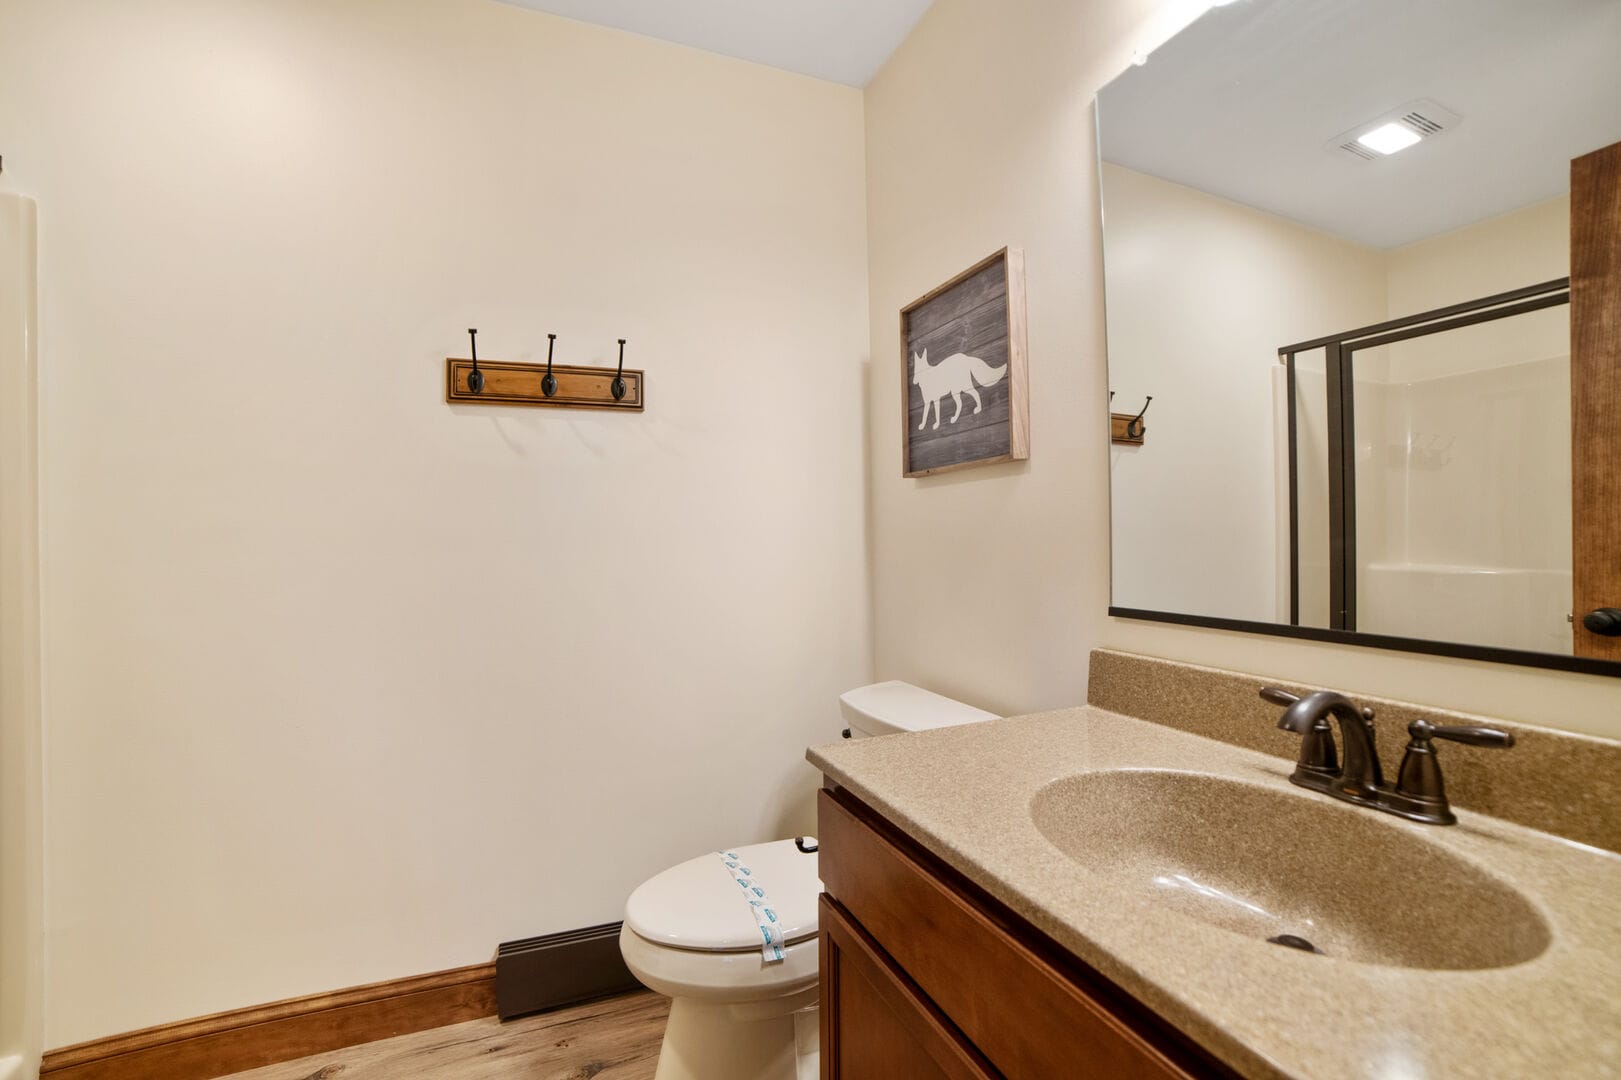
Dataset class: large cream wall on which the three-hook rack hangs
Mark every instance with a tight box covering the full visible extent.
[0,0,870,1046]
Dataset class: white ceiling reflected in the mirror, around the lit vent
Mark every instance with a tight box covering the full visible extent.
[1097,0,1621,248]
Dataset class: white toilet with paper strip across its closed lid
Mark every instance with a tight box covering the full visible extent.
[619,681,997,1080]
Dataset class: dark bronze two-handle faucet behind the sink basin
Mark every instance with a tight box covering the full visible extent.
[1261,686,1514,825]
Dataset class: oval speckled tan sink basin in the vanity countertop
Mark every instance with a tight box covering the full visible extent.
[1031,770,1550,970]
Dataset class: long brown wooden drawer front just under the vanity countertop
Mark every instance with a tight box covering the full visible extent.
[819,790,1232,1080]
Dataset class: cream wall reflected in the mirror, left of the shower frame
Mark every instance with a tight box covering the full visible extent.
[1102,164,1386,623]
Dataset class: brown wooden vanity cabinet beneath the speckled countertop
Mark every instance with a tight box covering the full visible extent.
[819,788,1235,1080]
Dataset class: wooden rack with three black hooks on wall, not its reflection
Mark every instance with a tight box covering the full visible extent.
[444,329,645,412]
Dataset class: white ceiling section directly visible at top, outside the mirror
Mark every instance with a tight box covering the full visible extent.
[506,0,934,86]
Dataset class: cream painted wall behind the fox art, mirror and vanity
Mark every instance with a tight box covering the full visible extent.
[867,0,1621,736]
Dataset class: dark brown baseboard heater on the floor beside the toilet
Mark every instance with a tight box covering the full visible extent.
[496,923,640,1020]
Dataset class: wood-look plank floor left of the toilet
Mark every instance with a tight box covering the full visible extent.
[222,991,669,1080]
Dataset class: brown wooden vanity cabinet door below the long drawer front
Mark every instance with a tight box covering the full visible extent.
[820,894,997,1080]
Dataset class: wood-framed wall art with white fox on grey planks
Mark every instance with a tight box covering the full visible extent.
[901,248,1029,477]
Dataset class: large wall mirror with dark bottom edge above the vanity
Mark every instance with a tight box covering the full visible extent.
[1097,0,1621,675]
